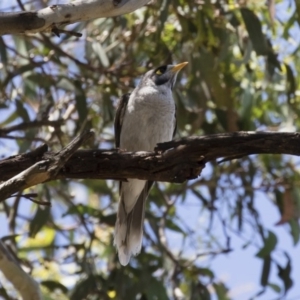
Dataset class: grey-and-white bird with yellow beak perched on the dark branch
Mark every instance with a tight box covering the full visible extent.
[114,62,188,266]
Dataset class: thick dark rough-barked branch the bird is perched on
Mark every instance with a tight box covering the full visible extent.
[0,132,300,200]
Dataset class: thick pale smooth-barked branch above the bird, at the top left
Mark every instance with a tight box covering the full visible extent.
[0,0,149,35]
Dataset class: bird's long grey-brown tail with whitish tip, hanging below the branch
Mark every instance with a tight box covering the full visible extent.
[114,184,148,266]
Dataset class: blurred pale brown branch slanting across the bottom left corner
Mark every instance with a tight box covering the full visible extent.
[0,240,43,300]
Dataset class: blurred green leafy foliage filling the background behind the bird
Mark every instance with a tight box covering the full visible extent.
[0,0,300,300]
